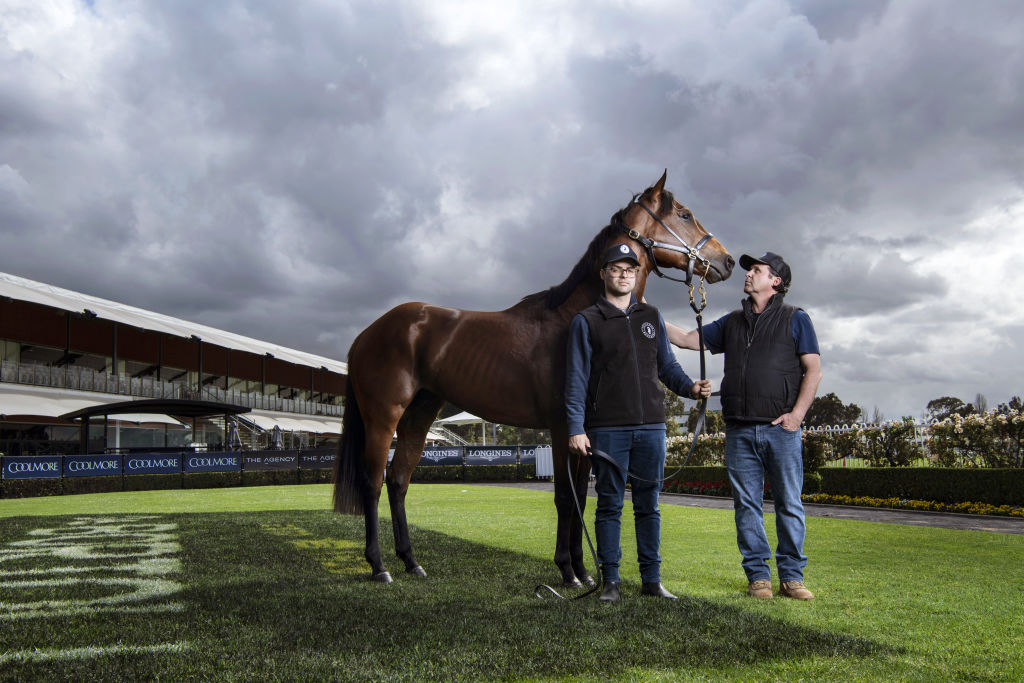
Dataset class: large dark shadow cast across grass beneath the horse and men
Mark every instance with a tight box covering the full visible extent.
[2,511,898,680]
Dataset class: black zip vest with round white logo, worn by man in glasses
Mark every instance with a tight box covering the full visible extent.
[581,297,665,429]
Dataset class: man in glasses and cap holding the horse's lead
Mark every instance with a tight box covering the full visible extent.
[565,245,711,602]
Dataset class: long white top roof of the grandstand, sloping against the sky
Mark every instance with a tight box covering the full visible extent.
[0,272,348,375]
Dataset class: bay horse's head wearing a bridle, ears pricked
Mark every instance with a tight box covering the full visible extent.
[613,171,736,284]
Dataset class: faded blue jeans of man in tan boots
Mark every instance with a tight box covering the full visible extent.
[725,424,807,581]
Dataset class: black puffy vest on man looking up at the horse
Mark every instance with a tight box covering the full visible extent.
[722,294,804,422]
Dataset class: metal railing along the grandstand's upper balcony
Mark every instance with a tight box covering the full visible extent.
[0,361,344,418]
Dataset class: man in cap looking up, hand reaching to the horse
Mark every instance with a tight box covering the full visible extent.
[669,252,821,600]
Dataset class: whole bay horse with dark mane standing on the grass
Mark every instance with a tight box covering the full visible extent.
[334,171,734,587]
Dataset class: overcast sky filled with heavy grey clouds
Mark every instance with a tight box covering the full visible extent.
[0,0,1024,418]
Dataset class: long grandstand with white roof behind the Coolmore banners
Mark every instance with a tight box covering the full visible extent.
[0,272,347,456]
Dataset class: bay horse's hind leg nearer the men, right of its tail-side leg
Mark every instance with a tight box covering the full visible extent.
[387,389,444,577]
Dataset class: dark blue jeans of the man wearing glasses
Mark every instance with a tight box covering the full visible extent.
[590,429,665,583]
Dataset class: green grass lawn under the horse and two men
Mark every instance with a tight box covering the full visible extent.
[0,484,1024,681]
